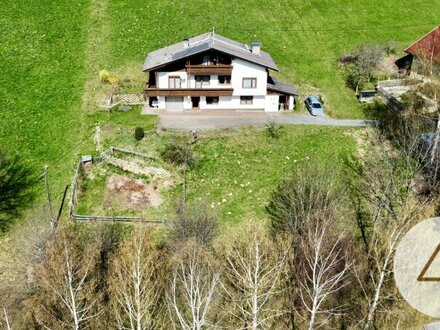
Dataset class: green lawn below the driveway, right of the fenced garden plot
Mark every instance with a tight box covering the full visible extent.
[188,126,356,223]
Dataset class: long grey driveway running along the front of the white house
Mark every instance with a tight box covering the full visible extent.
[143,110,374,131]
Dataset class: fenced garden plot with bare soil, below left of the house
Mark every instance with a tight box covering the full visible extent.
[73,152,176,220]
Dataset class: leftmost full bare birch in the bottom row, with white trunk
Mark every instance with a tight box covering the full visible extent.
[34,229,100,330]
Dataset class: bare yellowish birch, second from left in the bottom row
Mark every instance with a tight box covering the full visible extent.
[110,227,164,330]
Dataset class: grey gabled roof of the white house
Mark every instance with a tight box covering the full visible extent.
[144,32,278,71]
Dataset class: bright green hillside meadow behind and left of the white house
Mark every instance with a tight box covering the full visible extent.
[0,0,440,219]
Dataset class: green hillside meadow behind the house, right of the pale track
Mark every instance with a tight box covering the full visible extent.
[108,0,440,118]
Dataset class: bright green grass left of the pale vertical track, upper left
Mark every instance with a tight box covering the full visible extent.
[0,0,90,200]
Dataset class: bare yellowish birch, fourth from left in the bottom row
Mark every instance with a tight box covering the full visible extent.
[218,223,288,330]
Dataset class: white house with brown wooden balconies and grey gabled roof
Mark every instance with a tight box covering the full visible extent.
[144,32,298,112]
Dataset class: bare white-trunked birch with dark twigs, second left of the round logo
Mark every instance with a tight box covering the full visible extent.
[297,217,352,330]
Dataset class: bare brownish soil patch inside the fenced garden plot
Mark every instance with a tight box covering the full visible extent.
[104,175,163,209]
